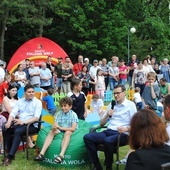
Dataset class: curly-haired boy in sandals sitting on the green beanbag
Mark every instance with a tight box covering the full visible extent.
[34,97,78,164]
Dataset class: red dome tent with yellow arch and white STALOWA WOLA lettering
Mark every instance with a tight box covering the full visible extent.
[7,37,68,73]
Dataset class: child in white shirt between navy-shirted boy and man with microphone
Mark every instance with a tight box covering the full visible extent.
[90,94,104,117]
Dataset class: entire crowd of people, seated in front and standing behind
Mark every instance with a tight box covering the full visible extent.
[0,55,170,170]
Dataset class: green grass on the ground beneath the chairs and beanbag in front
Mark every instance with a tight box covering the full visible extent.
[0,146,129,170]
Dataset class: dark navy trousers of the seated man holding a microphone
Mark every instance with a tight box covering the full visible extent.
[84,129,128,167]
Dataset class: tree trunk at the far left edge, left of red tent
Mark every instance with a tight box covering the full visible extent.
[0,9,9,60]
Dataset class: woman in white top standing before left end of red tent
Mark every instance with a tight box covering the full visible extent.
[14,64,27,87]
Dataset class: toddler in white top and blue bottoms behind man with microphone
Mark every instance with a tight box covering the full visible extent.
[133,87,143,110]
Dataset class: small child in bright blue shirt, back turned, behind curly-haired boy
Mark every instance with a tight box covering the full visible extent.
[41,88,57,116]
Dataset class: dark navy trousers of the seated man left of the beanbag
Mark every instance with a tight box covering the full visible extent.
[3,125,38,157]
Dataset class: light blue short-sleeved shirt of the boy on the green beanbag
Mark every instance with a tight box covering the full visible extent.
[55,110,78,128]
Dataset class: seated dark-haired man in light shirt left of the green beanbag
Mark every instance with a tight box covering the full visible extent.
[1,84,42,166]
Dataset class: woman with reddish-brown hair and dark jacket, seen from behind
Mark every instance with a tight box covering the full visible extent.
[125,109,170,170]
